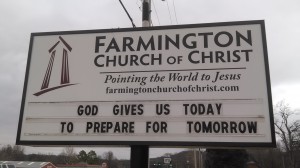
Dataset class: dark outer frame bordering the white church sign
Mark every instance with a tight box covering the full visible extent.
[16,20,276,147]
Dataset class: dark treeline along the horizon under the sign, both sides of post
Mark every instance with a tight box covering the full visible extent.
[0,143,300,168]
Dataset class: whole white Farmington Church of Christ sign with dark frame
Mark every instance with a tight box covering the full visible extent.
[17,21,275,147]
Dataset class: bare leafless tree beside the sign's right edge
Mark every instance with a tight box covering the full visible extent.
[275,101,300,168]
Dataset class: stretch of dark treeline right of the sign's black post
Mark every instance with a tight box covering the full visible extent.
[150,148,300,168]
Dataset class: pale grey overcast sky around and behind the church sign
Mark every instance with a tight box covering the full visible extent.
[0,0,300,158]
